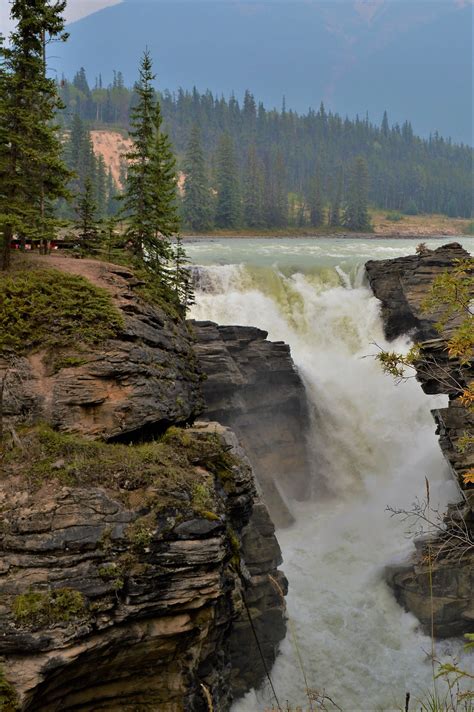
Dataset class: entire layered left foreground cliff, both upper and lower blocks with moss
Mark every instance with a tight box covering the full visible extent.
[0,258,286,712]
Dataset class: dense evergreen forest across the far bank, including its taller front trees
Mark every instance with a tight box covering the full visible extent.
[59,68,473,232]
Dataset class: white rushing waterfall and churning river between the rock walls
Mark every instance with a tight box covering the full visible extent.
[187,239,474,712]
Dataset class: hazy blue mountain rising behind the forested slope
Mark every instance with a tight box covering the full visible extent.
[52,0,472,143]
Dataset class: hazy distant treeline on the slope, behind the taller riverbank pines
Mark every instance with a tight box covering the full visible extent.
[60,69,473,227]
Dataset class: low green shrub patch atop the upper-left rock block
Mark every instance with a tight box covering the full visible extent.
[0,269,123,353]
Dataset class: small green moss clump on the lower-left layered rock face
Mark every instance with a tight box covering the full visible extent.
[13,588,86,627]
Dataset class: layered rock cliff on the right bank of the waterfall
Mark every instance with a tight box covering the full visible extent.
[366,243,474,637]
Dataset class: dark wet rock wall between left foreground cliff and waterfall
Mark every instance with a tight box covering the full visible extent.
[191,321,310,526]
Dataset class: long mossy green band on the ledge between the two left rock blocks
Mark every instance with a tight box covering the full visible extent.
[2,425,241,516]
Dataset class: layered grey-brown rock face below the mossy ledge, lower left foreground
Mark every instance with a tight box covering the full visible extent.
[0,423,285,712]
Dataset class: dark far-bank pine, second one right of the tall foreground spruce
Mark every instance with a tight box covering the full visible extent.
[216,134,240,228]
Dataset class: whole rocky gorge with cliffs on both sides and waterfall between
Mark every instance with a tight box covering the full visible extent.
[0,238,474,712]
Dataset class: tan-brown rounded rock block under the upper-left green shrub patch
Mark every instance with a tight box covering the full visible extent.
[0,258,203,439]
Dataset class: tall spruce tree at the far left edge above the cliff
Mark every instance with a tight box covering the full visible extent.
[0,0,69,269]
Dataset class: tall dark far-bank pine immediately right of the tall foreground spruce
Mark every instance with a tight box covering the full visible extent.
[183,124,212,232]
